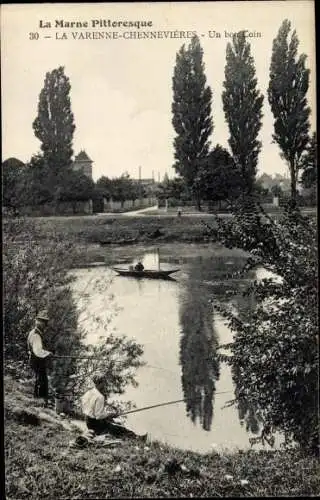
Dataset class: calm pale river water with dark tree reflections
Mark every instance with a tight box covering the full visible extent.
[73,243,276,452]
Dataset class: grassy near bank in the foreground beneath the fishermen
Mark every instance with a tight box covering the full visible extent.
[4,376,320,500]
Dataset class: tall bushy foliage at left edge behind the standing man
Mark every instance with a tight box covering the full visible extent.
[3,218,83,390]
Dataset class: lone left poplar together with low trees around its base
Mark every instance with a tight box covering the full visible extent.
[2,67,155,213]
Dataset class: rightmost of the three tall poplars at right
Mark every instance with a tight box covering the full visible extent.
[268,19,310,205]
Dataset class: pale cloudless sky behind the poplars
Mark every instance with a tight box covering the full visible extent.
[1,0,316,180]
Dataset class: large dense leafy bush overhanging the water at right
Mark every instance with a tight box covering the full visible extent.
[209,205,319,449]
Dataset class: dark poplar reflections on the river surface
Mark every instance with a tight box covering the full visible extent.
[179,257,260,434]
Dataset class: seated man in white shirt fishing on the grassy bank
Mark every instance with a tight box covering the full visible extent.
[81,374,147,441]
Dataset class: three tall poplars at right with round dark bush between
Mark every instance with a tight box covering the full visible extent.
[172,20,316,208]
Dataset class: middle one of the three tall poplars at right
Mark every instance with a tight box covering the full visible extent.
[222,31,263,195]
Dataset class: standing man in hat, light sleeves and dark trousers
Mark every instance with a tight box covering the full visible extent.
[27,311,52,406]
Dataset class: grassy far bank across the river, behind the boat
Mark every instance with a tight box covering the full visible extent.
[16,215,225,267]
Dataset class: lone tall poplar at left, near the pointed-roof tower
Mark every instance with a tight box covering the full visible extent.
[33,66,75,172]
